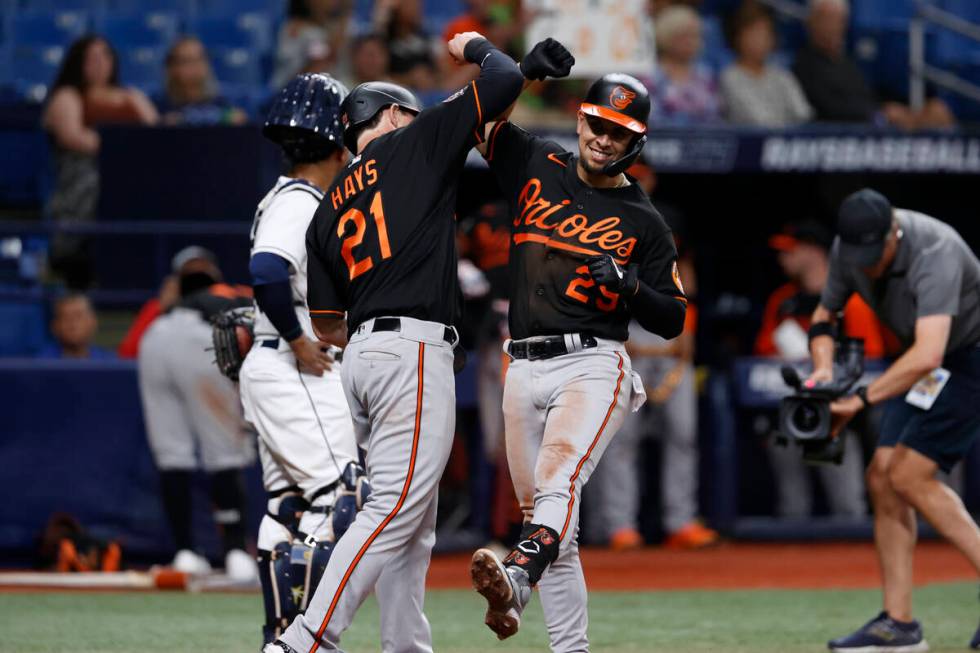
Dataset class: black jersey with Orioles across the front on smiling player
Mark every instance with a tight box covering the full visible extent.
[486,122,687,341]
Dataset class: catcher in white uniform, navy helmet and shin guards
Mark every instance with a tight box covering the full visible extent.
[239,73,363,643]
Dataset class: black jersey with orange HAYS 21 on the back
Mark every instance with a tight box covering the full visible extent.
[306,58,520,330]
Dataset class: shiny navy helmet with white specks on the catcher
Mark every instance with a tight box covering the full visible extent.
[262,73,347,163]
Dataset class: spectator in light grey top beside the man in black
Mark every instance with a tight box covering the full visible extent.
[721,0,813,127]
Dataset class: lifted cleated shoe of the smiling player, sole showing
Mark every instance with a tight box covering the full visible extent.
[470,549,531,639]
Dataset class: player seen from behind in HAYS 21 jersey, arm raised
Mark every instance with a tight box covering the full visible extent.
[270,32,572,653]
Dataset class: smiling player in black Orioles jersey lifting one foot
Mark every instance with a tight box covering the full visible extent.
[471,74,687,652]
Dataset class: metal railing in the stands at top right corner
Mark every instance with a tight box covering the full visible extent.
[909,1,980,110]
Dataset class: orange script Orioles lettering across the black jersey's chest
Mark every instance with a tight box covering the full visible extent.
[514,178,636,263]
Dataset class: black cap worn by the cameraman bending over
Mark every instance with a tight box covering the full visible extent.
[837,188,892,268]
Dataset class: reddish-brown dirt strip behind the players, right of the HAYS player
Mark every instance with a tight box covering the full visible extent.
[428,542,976,590]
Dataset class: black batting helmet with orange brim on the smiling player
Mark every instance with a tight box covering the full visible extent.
[579,73,650,177]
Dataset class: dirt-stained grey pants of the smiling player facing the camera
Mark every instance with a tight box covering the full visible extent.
[504,336,644,653]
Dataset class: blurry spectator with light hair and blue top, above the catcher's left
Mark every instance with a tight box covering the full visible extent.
[157,36,248,125]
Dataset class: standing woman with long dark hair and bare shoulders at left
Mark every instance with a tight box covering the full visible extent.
[41,36,158,289]
